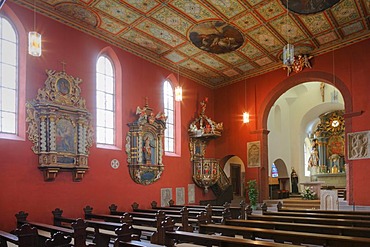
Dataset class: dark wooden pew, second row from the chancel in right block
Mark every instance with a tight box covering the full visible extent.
[262,203,370,222]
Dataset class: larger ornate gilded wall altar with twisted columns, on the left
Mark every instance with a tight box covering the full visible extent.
[26,70,93,181]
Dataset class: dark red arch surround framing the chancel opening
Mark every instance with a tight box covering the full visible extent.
[257,71,353,203]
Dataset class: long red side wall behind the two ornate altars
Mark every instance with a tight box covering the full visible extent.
[0,2,215,230]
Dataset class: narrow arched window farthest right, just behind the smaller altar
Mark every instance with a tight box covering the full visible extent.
[163,80,175,153]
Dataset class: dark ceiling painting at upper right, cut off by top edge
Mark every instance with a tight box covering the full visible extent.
[281,0,339,15]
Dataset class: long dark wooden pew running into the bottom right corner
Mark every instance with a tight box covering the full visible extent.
[199,224,370,247]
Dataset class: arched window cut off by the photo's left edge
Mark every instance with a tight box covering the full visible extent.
[0,16,19,135]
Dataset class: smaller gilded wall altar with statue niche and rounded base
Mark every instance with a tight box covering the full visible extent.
[126,103,167,185]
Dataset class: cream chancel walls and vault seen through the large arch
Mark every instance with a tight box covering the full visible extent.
[267,81,345,194]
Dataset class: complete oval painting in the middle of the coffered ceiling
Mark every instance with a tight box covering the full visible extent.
[189,21,244,54]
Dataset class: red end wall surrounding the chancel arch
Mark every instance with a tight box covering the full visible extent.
[215,39,370,205]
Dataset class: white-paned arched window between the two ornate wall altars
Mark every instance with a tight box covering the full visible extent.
[96,55,116,145]
